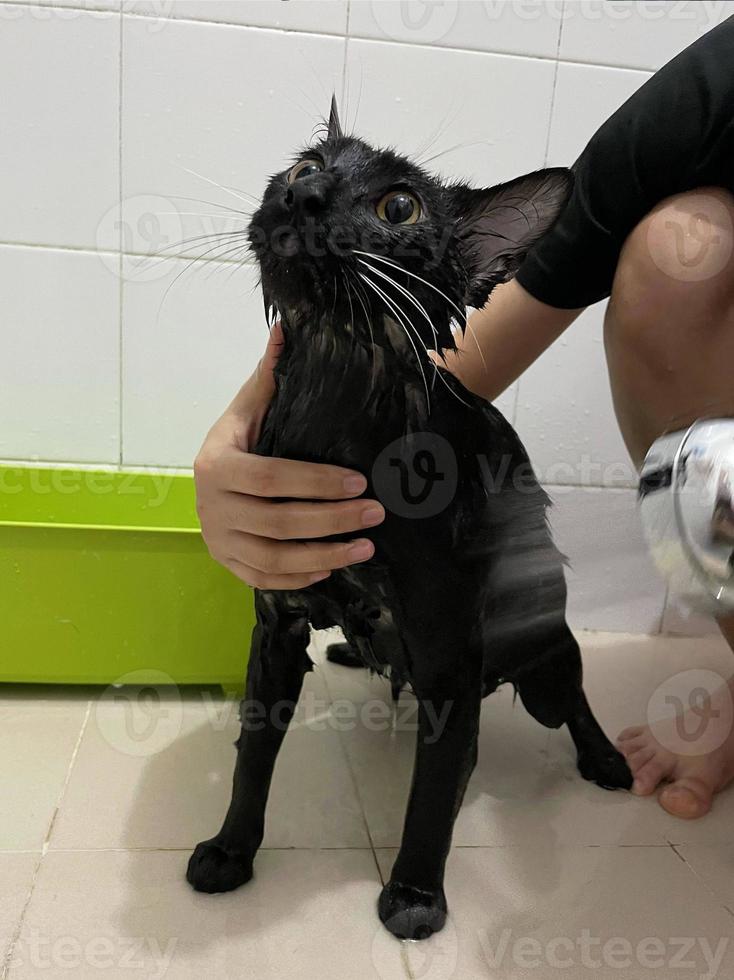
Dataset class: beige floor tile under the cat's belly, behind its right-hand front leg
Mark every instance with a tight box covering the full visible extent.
[334,688,670,847]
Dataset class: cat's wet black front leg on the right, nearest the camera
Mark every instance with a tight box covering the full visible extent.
[378,665,481,939]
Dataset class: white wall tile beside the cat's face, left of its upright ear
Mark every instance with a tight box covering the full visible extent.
[122,17,345,252]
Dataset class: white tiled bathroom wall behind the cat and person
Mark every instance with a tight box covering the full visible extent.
[0,0,734,632]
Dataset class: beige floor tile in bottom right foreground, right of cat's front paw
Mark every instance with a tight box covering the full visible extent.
[378,842,734,980]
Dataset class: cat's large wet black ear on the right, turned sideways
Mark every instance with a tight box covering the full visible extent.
[454,167,573,307]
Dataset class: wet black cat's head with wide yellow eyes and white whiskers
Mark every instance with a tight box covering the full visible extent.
[249,99,572,349]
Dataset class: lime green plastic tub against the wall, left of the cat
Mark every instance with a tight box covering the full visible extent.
[0,466,254,691]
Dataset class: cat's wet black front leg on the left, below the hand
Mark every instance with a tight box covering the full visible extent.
[186,593,312,892]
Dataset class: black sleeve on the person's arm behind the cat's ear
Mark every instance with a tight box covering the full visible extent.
[517,17,734,309]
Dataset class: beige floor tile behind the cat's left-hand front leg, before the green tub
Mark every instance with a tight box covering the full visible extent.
[46,671,369,849]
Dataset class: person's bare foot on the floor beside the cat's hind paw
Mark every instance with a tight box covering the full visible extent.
[617,677,734,820]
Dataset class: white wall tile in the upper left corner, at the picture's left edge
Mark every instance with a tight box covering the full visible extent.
[0,3,120,248]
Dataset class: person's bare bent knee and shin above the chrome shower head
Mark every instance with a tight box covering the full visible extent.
[604,187,734,463]
